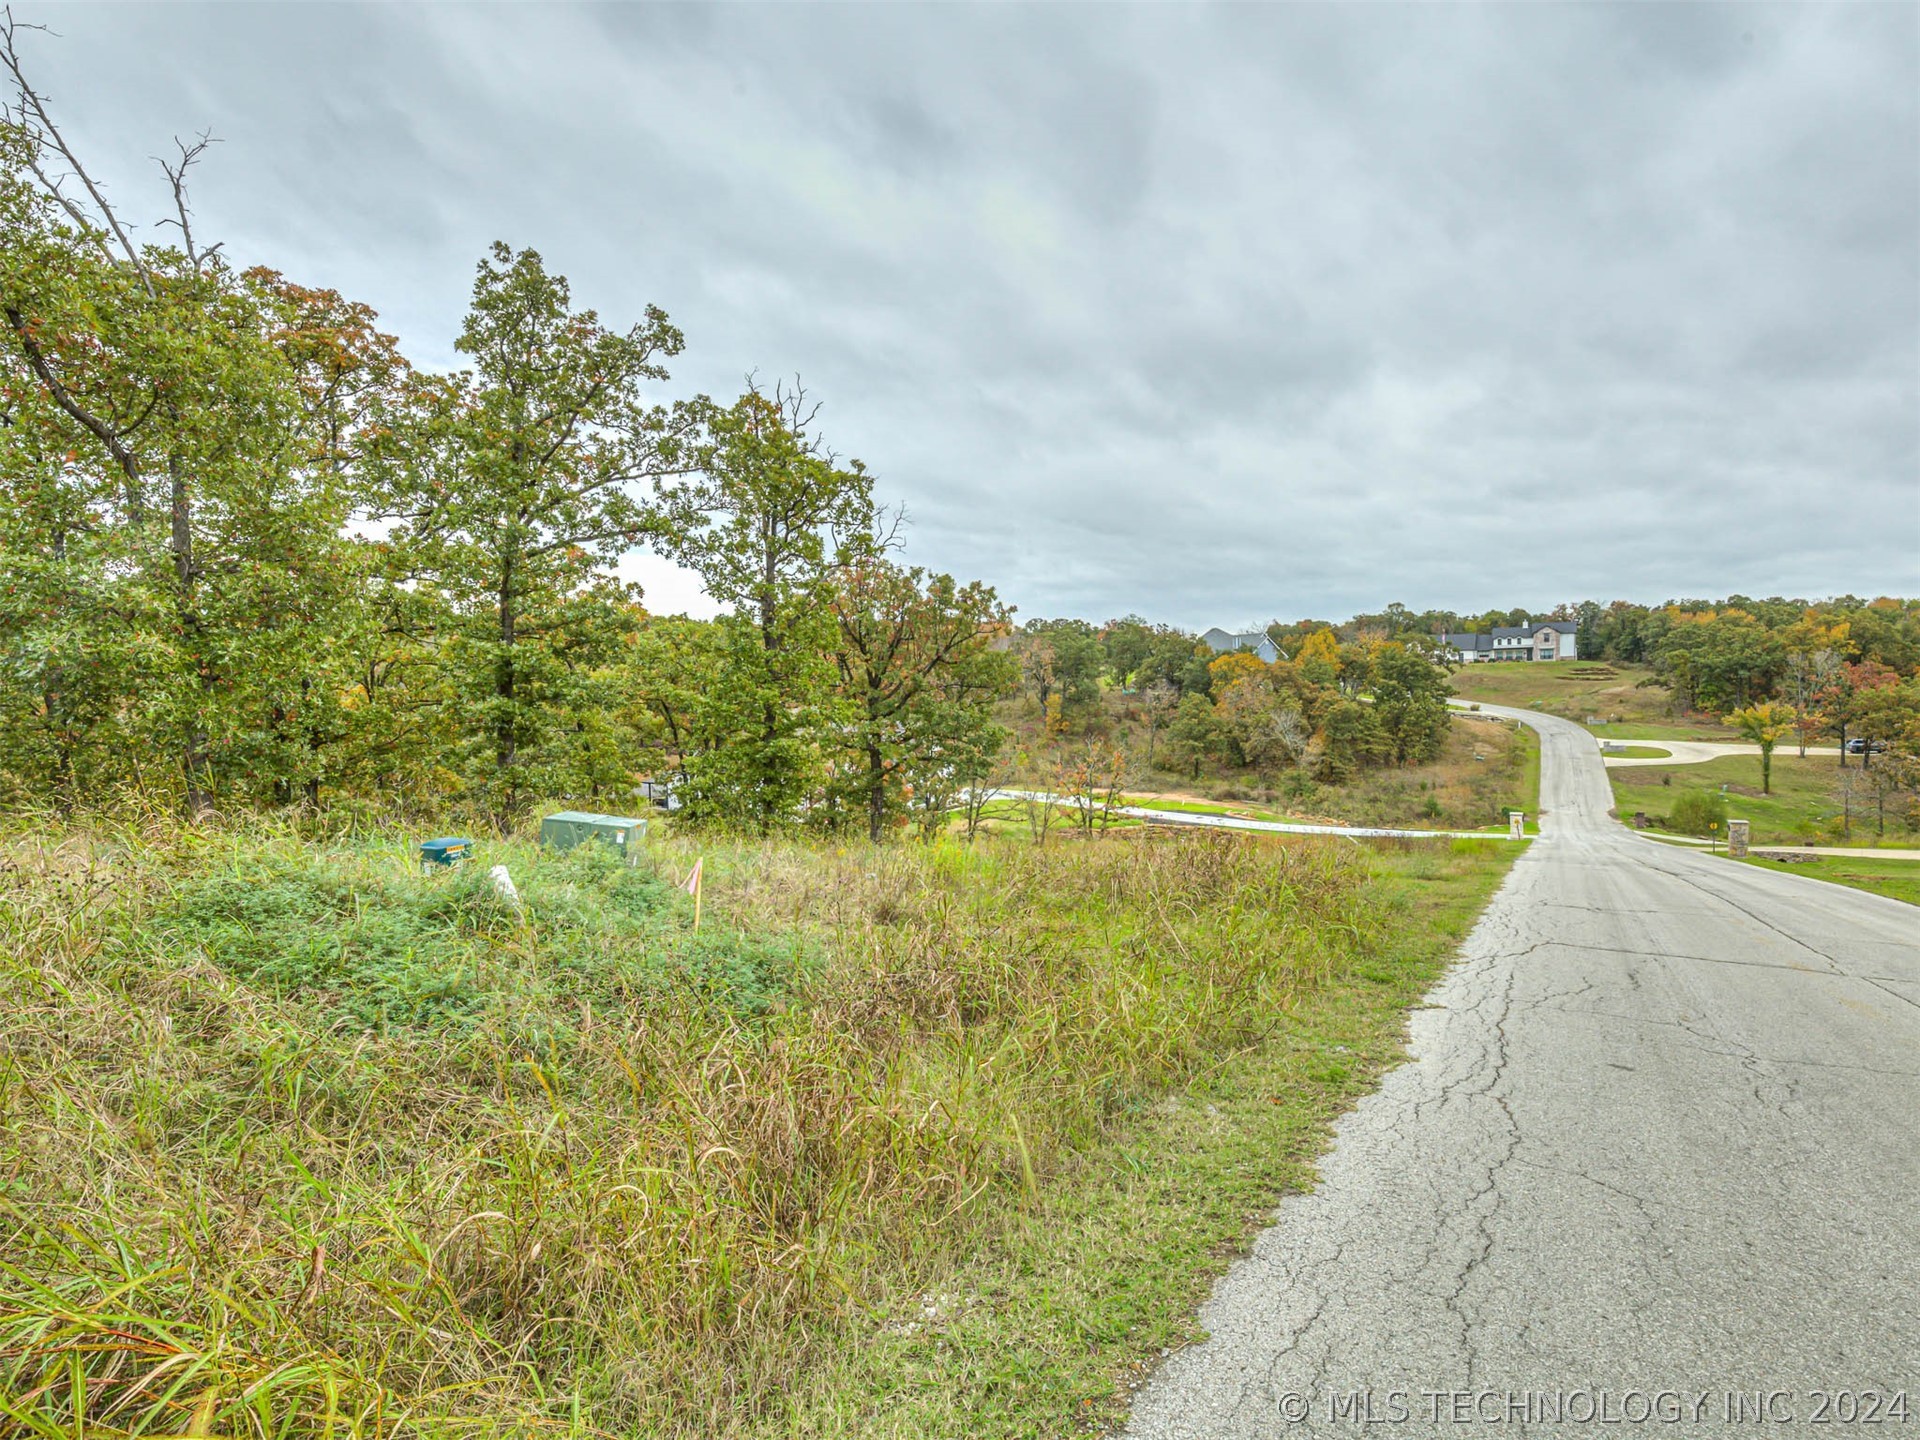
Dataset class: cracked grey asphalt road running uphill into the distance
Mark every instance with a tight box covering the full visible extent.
[1127,707,1920,1440]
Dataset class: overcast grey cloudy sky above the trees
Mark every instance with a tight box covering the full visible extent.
[15,0,1920,626]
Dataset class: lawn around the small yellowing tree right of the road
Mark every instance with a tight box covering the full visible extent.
[1607,753,1920,845]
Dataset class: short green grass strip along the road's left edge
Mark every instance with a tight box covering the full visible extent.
[785,841,1521,1440]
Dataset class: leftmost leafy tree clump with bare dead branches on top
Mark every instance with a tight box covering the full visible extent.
[0,50,372,814]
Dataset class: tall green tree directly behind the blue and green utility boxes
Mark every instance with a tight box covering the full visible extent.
[364,244,699,824]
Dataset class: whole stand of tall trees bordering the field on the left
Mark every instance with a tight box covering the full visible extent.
[0,45,1014,837]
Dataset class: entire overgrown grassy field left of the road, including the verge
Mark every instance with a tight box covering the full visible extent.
[0,826,1515,1436]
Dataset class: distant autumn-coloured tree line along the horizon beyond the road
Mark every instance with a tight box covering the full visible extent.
[1014,595,1920,821]
